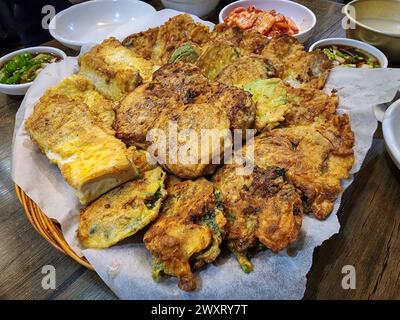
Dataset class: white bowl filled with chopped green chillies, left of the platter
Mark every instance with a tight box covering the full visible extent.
[0,47,67,95]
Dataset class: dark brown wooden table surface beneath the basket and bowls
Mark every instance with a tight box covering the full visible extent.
[0,0,400,299]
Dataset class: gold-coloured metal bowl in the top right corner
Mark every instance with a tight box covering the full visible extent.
[344,0,400,63]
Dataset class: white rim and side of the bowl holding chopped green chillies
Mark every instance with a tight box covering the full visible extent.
[0,47,67,95]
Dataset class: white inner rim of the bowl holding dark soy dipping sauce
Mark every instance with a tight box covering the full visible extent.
[309,38,388,68]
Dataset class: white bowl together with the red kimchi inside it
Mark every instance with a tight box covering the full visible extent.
[219,0,317,42]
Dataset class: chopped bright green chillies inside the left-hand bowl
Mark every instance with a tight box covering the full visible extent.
[0,53,61,84]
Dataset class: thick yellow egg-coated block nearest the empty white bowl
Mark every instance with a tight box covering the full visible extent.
[79,38,153,101]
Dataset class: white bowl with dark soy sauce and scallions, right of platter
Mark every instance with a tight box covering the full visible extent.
[309,38,388,68]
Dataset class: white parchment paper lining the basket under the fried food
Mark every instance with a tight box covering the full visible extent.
[12,13,400,299]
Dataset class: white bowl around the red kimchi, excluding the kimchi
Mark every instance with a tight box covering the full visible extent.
[219,0,317,42]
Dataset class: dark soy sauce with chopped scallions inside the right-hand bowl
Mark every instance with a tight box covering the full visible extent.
[319,45,381,69]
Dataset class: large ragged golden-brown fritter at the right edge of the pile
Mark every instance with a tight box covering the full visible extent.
[247,115,354,219]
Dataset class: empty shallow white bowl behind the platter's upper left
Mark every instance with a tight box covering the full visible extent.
[49,0,156,50]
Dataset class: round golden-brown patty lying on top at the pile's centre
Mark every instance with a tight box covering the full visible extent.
[152,103,230,179]
